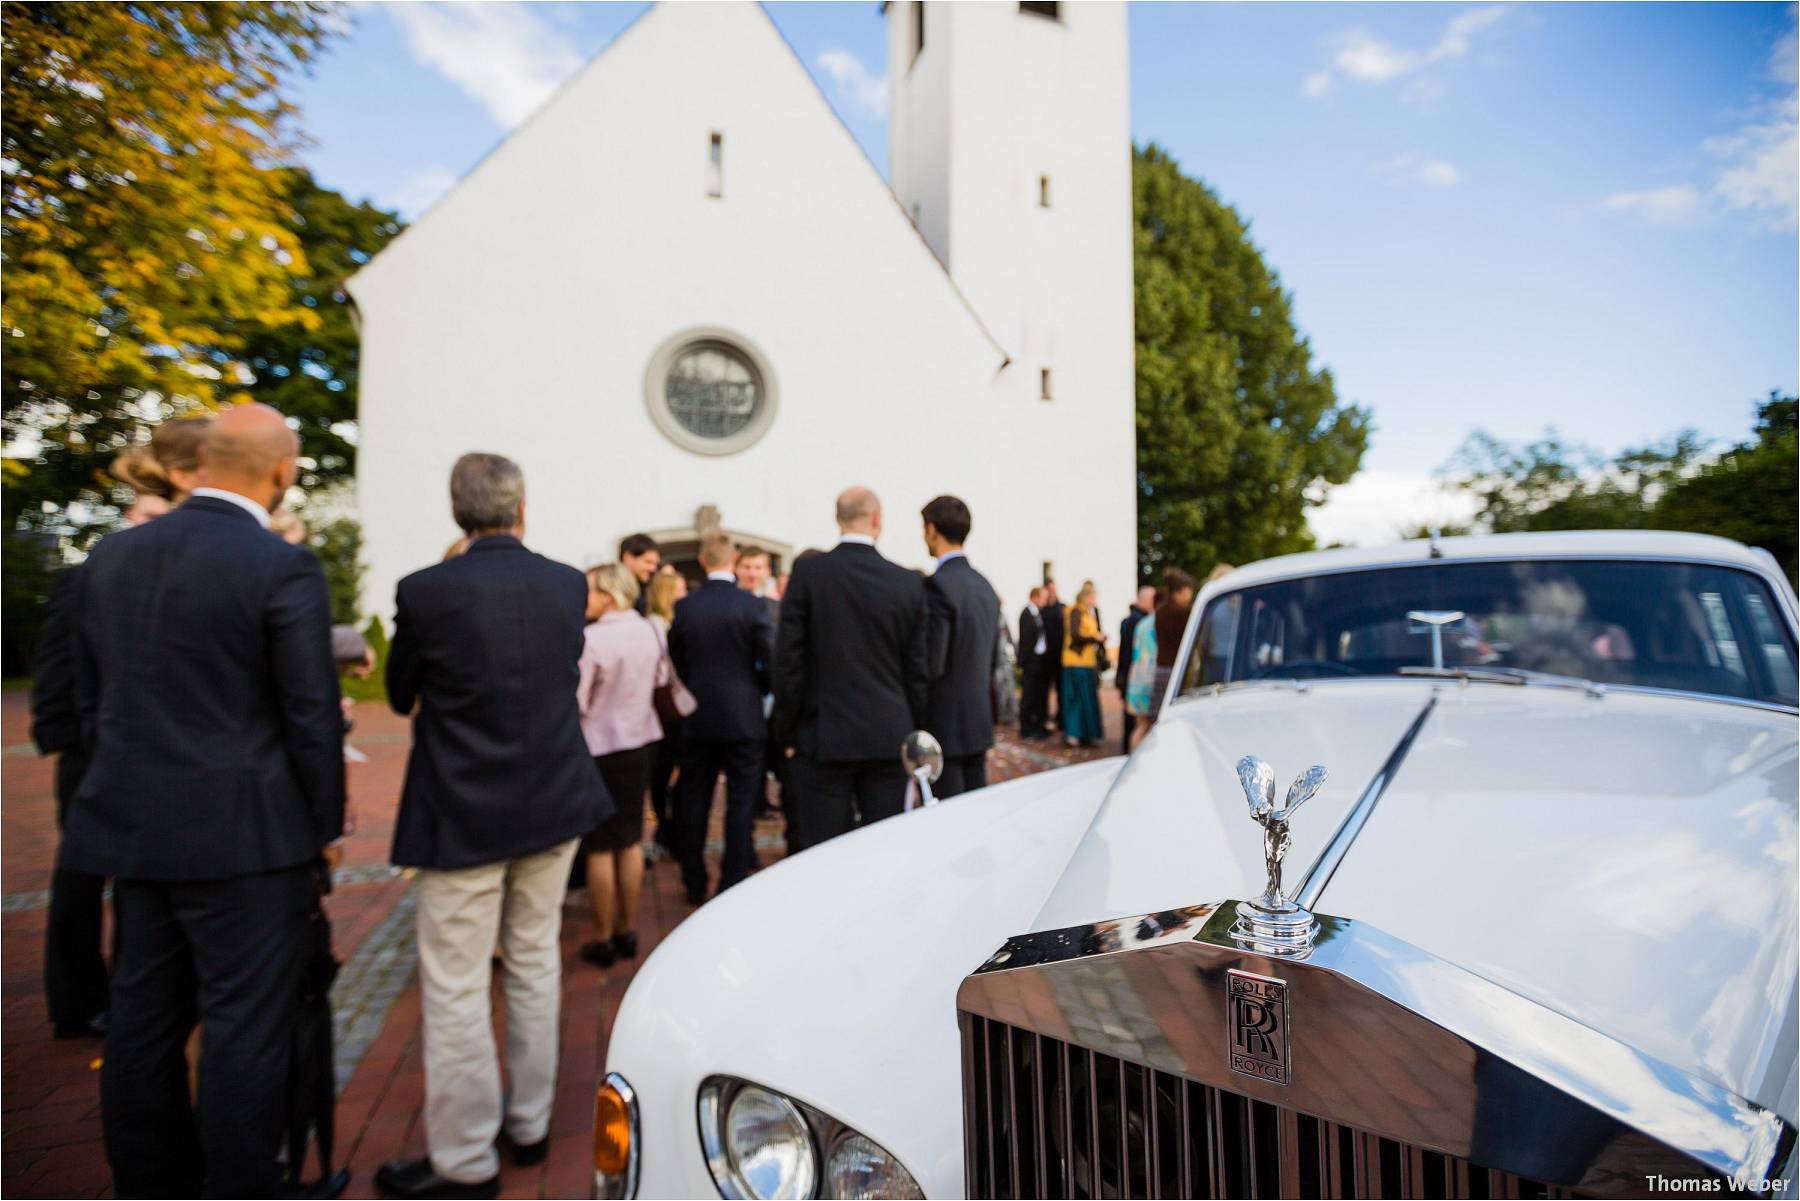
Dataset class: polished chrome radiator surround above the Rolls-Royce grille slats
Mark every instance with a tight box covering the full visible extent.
[956,900,1793,1196]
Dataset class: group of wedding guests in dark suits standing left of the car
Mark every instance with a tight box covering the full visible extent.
[32,417,1029,1197]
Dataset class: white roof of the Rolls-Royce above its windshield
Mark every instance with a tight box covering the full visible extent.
[1206,529,1773,594]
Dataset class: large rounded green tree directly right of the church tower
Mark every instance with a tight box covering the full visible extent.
[1132,144,1370,580]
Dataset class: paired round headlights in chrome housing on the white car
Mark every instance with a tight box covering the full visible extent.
[698,1077,923,1201]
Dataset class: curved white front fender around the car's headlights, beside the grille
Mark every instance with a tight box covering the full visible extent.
[607,758,1121,1197]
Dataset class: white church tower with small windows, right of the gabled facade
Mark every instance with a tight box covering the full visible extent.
[887,0,1138,614]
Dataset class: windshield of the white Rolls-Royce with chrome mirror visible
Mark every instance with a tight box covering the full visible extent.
[1183,560,1796,704]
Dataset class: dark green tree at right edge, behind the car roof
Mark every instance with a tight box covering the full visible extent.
[1651,393,1800,580]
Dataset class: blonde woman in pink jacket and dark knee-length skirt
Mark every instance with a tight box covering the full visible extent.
[576,564,668,967]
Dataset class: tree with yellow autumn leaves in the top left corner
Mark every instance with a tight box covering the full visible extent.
[0,0,328,544]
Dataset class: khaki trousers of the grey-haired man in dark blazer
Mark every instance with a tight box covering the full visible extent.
[418,839,576,1183]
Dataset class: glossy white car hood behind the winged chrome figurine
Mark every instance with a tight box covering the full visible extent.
[1031,681,1800,1122]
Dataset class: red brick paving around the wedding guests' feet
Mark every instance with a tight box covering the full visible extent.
[0,690,1120,1197]
